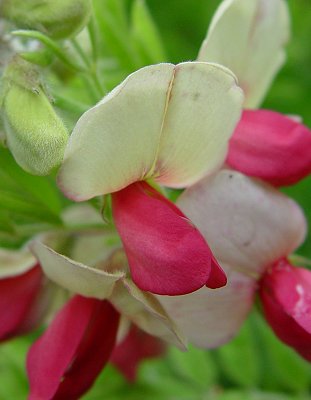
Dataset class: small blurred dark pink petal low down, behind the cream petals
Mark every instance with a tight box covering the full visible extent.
[110,325,166,382]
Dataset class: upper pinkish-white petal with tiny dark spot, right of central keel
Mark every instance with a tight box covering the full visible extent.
[177,170,306,276]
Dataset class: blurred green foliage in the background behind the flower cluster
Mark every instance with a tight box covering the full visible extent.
[0,0,311,400]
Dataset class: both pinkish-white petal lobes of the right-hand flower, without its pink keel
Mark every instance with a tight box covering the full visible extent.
[159,169,306,347]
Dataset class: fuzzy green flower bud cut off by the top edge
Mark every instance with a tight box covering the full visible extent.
[0,0,92,39]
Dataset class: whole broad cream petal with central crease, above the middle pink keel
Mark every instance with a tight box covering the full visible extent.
[59,63,243,201]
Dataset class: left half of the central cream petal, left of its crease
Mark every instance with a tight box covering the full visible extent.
[59,64,174,201]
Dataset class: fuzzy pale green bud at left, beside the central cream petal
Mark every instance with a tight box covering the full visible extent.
[1,59,68,175]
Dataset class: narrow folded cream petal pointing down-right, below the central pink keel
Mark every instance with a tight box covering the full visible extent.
[110,279,186,350]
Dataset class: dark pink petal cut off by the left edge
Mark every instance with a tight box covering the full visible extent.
[0,266,43,341]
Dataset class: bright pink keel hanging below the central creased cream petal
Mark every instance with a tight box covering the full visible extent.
[112,182,227,295]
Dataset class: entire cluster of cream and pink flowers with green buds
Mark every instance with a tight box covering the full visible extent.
[0,0,311,400]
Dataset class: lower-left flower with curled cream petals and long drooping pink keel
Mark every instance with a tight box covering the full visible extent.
[27,241,185,399]
